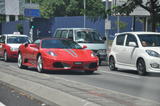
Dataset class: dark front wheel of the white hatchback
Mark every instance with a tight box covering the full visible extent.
[137,59,147,76]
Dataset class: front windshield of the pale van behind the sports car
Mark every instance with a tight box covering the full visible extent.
[75,30,104,43]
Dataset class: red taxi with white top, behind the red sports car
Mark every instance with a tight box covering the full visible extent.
[0,34,30,61]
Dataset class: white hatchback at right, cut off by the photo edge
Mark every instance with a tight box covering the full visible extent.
[109,32,160,75]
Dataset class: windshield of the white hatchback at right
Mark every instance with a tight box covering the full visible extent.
[138,34,160,47]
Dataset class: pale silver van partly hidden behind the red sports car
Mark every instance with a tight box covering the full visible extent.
[53,28,107,65]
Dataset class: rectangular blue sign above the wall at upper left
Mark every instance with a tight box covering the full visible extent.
[24,8,40,17]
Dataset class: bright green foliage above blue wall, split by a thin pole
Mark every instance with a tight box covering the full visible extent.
[37,0,105,19]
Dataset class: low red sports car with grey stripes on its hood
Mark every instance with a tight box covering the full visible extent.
[18,38,99,74]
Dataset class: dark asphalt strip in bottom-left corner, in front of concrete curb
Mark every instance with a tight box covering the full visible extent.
[0,82,48,106]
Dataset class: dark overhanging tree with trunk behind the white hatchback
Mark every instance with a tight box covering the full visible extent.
[113,0,160,31]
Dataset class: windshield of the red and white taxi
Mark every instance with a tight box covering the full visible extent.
[7,36,29,44]
